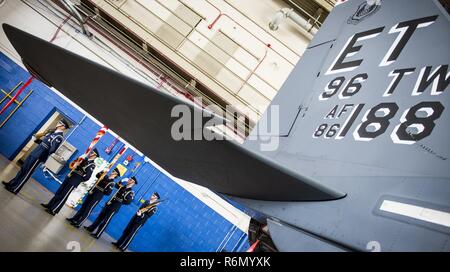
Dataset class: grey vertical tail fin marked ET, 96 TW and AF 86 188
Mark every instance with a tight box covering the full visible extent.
[249,0,450,181]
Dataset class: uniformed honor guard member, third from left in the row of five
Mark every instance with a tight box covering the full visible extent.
[66,168,121,228]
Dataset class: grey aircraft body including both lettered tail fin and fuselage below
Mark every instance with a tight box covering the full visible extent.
[243,0,450,251]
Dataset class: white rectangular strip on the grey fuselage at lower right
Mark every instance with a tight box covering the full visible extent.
[380,200,450,227]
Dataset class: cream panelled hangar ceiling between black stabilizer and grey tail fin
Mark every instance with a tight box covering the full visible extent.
[52,0,334,137]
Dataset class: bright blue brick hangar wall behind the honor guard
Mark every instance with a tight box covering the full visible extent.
[0,53,248,251]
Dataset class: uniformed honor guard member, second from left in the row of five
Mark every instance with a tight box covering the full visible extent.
[41,148,99,215]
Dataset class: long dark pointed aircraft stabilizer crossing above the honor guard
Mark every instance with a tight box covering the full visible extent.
[3,24,345,201]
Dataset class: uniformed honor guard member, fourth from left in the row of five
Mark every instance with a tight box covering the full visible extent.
[84,177,137,239]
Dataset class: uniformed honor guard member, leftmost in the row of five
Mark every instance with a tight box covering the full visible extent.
[2,119,69,194]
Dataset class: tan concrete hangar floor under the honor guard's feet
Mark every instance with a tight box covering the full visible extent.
[0,155,118,252]
